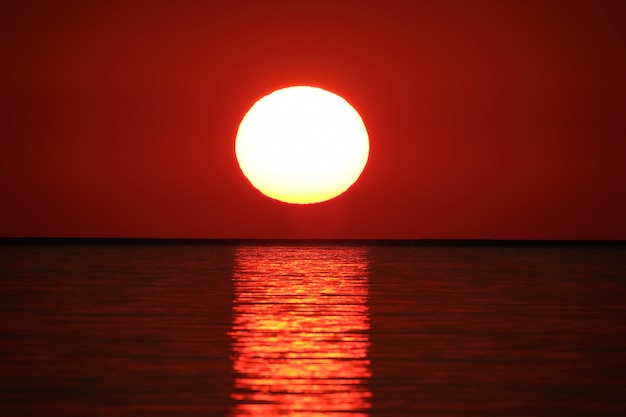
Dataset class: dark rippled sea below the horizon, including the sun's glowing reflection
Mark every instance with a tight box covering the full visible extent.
[0,240,626,417]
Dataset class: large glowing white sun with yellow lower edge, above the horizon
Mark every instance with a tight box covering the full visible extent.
[235,86,370,204]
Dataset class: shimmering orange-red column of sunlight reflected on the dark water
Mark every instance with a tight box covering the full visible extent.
[230,246,371,417]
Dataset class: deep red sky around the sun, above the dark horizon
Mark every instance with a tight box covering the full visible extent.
[0,0,626,239]
